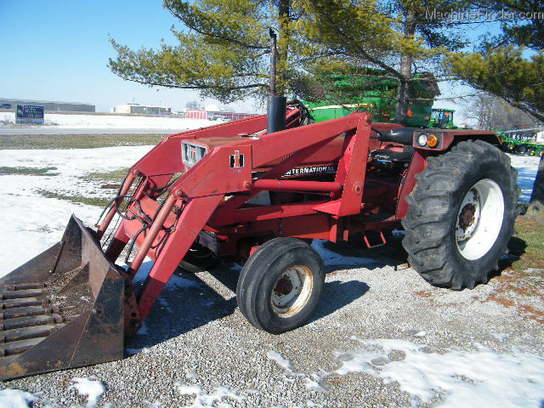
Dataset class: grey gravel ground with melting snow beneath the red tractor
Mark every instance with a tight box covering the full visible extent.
[4,237,544,408]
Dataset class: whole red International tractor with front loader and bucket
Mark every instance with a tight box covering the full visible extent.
[0,105,518,379]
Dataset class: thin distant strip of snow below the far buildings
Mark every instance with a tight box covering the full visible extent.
[0,112,216,131]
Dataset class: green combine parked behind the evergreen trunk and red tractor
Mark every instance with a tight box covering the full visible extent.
[304,68,455,129]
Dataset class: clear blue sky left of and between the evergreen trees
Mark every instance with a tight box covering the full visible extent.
[0,0,506,119]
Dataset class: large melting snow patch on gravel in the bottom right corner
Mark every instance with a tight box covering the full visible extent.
[336,339,544,408]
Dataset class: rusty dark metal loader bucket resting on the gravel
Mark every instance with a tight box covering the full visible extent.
[0,216,133,380]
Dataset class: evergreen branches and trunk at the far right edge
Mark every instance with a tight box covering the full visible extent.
[446,0,544,214]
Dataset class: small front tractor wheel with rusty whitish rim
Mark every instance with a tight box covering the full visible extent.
[236,238,325,334]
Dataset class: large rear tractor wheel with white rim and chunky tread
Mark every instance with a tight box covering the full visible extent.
[402,140,519,290]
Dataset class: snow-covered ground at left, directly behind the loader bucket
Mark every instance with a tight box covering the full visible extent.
[0,146,151,276]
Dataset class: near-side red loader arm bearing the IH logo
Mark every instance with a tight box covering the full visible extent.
[99,114,370,319]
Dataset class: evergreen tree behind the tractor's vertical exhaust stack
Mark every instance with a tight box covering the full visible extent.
[109,0,289,102]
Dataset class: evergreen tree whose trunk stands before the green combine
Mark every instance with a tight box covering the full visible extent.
[299,0,470,121]
